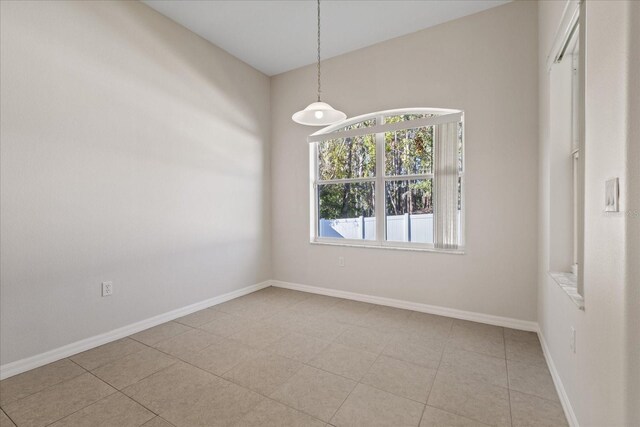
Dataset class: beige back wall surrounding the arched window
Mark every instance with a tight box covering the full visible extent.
[271,2,538,320]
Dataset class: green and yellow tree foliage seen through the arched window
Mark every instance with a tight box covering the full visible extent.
[318,114,433,219]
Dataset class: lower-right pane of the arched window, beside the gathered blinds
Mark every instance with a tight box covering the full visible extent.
[385,179,433,243]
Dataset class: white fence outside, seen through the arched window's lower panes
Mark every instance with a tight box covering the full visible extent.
[319,214,433,243]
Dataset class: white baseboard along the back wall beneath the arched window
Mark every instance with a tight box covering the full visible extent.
[271,280,538,332]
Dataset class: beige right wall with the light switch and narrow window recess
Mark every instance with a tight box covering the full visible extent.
[538,0,640,426]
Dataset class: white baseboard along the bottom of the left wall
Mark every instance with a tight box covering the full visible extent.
[0,280,271,379]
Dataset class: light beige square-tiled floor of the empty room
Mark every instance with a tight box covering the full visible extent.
[0,287,567,427]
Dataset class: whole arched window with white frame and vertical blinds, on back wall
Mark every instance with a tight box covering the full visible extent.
[308,108,464,252]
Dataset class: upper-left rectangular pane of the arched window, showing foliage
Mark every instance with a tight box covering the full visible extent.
[318,135,376,181]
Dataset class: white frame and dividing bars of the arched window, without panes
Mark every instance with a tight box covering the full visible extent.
[307,108,466,254]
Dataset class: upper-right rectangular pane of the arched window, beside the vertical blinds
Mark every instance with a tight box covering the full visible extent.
[384,126,433,176]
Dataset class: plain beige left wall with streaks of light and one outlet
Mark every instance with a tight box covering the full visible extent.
[0,1,271,364]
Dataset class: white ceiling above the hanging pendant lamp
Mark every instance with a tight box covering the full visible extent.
[143,0,510,76]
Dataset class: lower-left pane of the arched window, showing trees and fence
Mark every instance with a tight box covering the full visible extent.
[318,182,376,240]
